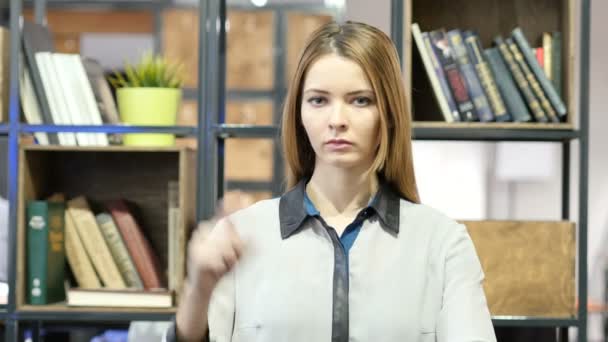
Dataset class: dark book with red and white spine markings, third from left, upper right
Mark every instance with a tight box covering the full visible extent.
[429,30,479,121]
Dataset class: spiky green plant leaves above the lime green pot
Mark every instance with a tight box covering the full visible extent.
[108,53,183,89]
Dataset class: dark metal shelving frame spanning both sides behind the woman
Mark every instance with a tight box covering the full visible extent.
[0,0,590,342]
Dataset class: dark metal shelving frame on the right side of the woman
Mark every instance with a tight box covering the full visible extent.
[391,0,591,341]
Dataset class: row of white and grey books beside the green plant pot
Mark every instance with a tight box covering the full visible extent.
[18,20,120,146]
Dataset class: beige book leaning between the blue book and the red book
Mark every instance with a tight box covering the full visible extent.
[96,213,144,289]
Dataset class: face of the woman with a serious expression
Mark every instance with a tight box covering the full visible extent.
[301,54,380,170]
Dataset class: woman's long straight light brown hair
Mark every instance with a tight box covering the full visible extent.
[281,21,420,203]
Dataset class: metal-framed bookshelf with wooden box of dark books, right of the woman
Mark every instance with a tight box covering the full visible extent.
[391,0,590,341]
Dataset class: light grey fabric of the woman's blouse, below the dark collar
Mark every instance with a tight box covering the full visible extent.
[168,182,496,342]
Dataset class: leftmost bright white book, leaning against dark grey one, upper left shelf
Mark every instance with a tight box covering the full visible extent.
[35,52,77,146]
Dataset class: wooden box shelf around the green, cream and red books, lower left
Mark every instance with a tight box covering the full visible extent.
[15,145,196,312]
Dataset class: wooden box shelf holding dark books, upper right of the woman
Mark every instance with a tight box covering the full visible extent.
[403,0,578,124]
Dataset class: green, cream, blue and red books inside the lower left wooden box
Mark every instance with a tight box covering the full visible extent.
[26,184,185,308]
